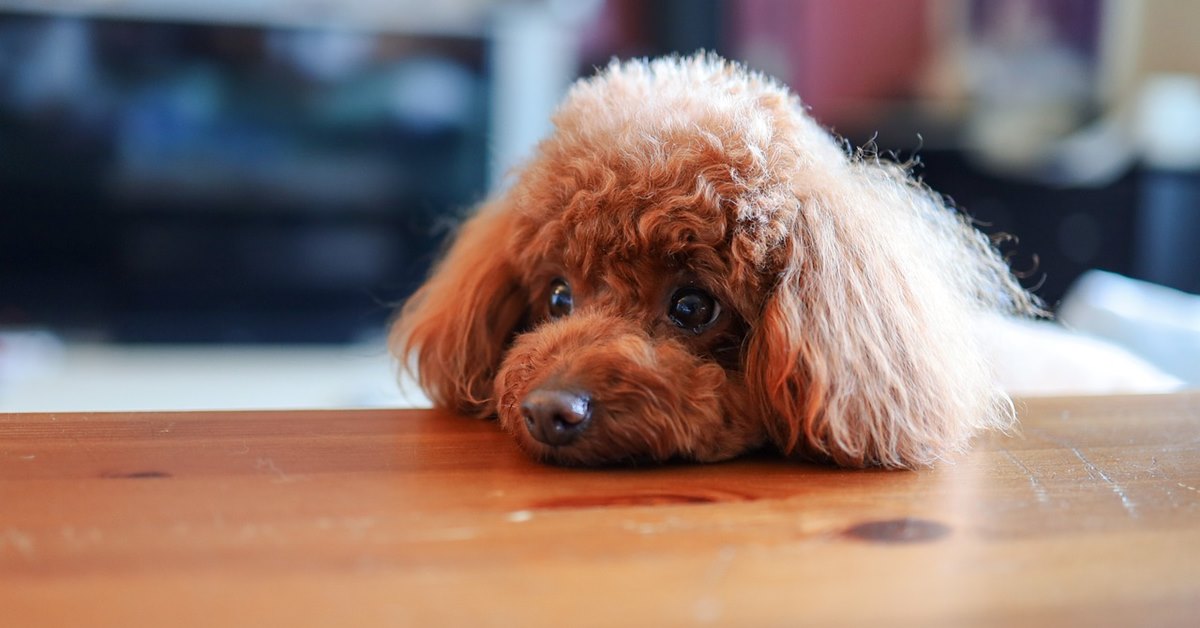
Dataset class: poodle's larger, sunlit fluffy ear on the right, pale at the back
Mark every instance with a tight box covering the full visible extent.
[745,161,1032,467]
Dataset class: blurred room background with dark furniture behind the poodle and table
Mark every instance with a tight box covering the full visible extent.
[0,0,1200,411]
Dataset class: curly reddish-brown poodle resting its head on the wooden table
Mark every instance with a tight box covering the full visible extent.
[390,55,1037,467]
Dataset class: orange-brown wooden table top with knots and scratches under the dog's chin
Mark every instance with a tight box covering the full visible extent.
[0,394,1200,627]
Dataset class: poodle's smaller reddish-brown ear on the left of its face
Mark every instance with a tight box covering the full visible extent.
[388,199,529,417]
